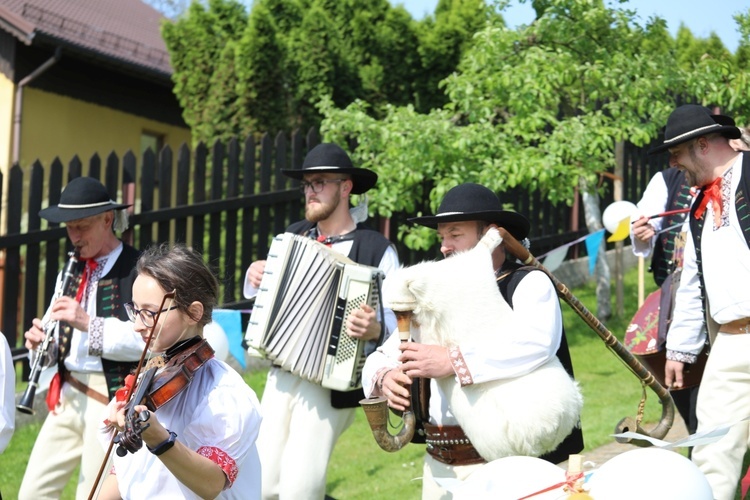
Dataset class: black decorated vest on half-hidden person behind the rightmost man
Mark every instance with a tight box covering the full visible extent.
[651,168,690,286]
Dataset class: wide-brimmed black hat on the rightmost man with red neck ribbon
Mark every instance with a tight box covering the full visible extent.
[648,104,742,155]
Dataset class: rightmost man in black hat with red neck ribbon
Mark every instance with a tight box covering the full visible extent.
[650,105,750,500]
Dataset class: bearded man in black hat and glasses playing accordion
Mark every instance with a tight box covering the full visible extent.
[244,143,398,499]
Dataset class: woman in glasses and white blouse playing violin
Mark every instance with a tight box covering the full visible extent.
[98,245,261,499]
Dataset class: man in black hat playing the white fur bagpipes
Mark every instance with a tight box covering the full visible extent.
[362,183,583,499]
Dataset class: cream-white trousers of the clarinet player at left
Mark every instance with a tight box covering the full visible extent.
[18,372,107,500]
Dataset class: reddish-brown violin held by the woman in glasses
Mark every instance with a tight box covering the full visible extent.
[114,337,214,457]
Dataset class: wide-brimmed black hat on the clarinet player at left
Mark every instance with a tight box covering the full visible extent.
[39,177,130,223]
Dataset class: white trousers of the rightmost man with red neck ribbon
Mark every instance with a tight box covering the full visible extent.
[692,332,750,500]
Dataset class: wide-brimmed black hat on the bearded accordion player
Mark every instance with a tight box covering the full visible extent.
[281,143,378,194]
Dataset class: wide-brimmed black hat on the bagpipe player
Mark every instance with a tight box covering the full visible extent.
[408,183,530,240]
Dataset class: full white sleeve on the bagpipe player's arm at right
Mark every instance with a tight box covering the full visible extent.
[459,271,562,384]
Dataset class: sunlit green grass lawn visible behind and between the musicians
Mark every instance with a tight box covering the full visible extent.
[0,269,692,500]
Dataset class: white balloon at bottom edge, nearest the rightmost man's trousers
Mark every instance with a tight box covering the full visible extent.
[587,448,713,500]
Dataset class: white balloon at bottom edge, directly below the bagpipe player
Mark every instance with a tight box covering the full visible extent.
[450,457,565,500]
